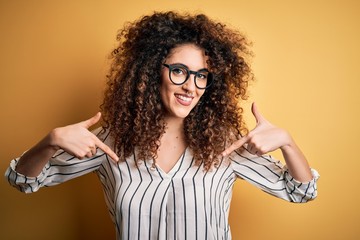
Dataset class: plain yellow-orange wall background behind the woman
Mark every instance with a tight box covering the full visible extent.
[0,0,360,240]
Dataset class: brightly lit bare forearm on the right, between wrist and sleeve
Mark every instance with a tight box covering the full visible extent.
[280,136,313,182]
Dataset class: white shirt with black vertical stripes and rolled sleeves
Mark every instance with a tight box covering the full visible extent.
[5,127,319,240]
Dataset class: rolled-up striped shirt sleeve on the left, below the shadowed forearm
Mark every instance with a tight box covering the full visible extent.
[5,127,109,193]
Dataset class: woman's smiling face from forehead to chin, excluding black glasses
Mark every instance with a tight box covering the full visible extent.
[160,44,207,119]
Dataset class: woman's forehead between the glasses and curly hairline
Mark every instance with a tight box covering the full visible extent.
[166,44,208,69]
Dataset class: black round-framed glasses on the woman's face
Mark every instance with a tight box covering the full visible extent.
[163,63,213,89]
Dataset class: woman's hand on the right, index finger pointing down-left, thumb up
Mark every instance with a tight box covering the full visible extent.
[222,103,291,157]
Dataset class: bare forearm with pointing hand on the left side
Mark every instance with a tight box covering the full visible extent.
[16,113,118,177]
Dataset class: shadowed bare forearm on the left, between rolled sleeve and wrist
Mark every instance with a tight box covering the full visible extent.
[16,133,57,177]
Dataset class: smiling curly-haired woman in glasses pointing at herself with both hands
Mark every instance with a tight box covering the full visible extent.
[6,12,318,239]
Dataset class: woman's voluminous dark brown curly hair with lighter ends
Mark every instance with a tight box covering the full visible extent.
[101,12,253,170]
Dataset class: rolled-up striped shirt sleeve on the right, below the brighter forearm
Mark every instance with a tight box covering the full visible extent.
[230,149,320,203]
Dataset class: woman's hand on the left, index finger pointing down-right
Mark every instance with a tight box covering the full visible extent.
[50,112,119,162]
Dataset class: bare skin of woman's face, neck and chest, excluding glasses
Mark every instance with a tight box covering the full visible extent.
[156,44,207,173]
